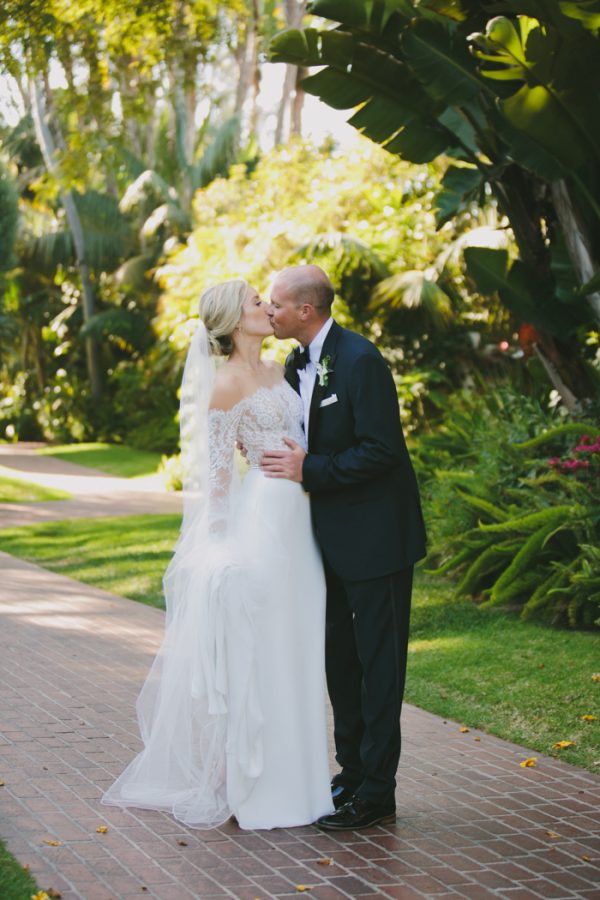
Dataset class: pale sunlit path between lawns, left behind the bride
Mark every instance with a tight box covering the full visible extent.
[0,443,181,528]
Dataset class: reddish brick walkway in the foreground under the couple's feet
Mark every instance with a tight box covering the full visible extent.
[0,554,600,900]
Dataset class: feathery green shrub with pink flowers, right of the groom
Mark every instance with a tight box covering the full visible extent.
[418,385,600,626]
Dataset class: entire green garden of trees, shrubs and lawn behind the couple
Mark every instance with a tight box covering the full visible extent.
[0,0,600,844]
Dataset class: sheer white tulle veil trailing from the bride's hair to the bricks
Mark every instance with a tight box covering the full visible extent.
[102,320,262,828]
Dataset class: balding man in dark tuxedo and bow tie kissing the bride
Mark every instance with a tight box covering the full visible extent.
[261,266,425,831]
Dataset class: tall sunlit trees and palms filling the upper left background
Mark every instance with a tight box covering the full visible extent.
[0,0,304,448]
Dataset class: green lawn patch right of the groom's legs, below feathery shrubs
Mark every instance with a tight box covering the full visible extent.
[406,575,600,773]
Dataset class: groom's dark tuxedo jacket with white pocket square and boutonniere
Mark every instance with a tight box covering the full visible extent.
[285,322,425,581]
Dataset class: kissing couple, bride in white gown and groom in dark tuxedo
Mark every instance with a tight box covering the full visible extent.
[103,265,425,830]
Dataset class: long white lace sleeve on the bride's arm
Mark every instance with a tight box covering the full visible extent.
[208,409,237,535]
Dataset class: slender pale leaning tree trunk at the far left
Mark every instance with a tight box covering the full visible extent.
[30,79,102,400]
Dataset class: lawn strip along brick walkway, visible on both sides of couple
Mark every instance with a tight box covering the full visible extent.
[0,515,600,772]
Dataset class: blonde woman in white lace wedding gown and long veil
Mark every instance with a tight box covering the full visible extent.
[102,280,333,829]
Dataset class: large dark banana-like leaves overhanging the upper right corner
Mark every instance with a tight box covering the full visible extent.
[271,0,600,408]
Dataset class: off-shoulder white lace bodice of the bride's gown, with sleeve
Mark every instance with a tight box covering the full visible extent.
[208,381,306,522]
